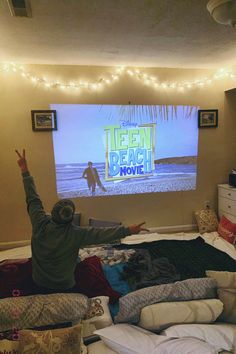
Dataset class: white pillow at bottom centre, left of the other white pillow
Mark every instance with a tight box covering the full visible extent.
[95,324,217,354]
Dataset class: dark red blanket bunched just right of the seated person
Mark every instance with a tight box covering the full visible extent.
[75,256,120,303]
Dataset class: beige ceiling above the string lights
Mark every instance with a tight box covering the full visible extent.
[0,0,236,68]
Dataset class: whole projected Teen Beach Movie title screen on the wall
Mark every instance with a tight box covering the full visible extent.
[51,104,198,198]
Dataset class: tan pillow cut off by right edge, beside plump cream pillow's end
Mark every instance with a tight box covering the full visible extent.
[217,289,236,324]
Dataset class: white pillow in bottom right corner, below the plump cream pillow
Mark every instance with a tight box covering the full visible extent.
[161,323,235,351]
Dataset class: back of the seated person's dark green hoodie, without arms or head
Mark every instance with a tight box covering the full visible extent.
[31,220,79,290]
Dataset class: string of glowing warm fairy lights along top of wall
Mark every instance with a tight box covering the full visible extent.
[1,63,236,92]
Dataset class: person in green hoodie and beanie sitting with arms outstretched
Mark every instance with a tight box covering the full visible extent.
[16,150,148,294]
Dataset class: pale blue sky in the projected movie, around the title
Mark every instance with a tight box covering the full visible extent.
[51,104,198,164]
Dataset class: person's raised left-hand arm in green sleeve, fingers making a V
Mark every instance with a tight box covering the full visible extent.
[15,149,47,228]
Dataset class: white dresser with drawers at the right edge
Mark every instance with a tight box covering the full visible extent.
[218,184,236,223]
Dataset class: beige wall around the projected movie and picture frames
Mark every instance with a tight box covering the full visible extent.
[0,66,236,241]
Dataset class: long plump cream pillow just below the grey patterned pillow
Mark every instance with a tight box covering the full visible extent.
[138,299,223,330]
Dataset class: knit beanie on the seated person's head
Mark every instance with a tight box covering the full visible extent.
[51,199,75,224]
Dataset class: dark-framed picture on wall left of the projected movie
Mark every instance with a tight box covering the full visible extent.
[31,110,57,131]
